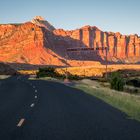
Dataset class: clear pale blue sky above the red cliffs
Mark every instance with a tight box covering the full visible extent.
[0,0,140,35]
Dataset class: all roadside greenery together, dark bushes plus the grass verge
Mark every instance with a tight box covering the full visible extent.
[36,67,140,121]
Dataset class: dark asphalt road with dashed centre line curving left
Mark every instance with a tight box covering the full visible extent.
[0,76,140,140]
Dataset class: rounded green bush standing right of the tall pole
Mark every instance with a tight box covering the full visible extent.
[110,72,124,91]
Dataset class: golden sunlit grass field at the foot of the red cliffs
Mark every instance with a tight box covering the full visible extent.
[18,64,140,77]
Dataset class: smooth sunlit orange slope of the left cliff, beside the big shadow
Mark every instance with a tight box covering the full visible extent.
[0,22,63,65]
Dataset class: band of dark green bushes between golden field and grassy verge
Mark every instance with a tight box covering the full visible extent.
[36,67,140,94]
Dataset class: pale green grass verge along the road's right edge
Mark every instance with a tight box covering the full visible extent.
[75,83,140,121]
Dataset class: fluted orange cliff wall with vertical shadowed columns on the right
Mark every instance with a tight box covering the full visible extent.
[54,26,140,63]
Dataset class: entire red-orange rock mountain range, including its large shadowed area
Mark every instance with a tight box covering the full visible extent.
[0,17,140,66]
